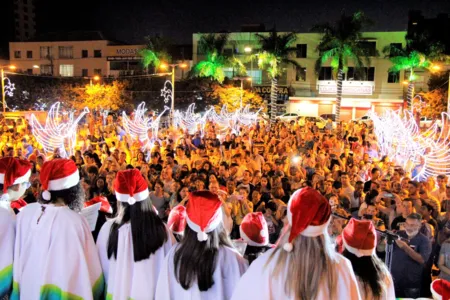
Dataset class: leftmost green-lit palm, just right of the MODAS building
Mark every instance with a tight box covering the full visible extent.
[139,35,172,73]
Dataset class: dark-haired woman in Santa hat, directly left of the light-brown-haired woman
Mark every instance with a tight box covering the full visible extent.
[155,191,247,299]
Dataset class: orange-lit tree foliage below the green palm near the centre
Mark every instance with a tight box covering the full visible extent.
[211,84,264,111]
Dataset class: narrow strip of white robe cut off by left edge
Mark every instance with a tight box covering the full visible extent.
[0,206,16,299]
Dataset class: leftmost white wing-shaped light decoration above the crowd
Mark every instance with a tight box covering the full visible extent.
[30,102,89,158]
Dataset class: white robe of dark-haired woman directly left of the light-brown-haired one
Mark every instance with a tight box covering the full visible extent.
[156,247,250,300]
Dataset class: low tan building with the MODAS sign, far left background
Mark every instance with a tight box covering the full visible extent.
[9,32,192,79]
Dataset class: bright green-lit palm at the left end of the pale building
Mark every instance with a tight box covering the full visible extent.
[193,33,246,83]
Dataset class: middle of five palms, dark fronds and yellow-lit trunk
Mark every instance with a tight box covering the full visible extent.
[256,28,300,123]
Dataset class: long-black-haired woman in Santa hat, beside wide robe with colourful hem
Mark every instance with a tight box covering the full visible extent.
[97,169,175,299]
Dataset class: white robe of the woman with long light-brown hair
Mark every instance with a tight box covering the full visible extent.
[232,249,361,300]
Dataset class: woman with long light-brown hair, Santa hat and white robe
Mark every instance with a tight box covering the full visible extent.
[231,187,361,300]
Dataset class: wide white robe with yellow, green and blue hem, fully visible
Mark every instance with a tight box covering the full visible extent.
[11,203,104,300]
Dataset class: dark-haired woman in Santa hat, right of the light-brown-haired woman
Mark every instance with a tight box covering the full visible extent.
[342,219,395,300]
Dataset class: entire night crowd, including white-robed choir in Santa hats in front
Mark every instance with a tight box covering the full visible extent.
[0,111,450,299]
